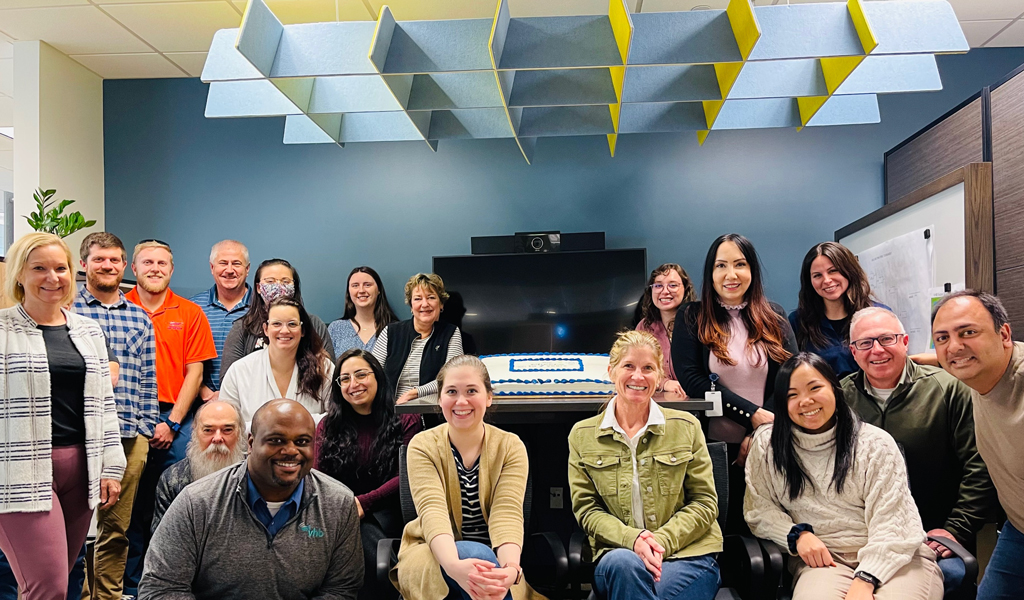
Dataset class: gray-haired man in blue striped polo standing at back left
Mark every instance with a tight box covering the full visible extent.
[189,240,252,401]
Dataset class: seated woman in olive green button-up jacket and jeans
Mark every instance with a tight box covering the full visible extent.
[569,331,722,600]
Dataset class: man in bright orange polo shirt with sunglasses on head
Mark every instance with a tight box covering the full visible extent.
[124,240,217,595]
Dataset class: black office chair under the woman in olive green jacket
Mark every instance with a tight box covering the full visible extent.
[568,441,772,600]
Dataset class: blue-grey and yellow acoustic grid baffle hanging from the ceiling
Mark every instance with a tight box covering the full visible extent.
[202,0,970,163]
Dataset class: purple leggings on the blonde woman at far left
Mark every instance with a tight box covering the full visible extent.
[0,445,92,600]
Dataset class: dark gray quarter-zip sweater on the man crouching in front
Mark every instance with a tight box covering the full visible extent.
[138,462,364,600]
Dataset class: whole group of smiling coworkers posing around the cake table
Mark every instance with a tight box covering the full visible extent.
[0,232,1024,600]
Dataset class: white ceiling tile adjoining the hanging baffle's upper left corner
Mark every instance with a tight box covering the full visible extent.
[103,0,242,52]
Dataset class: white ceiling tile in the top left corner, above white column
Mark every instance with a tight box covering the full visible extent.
[0,6,150,54]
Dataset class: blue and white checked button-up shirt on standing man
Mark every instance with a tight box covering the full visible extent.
[72,287,160,437]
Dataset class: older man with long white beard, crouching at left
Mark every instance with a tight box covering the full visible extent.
[153,400,246,531]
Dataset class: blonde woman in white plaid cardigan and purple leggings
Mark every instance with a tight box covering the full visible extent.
[0,233,125,600]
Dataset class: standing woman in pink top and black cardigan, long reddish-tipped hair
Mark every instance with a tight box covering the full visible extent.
[672,233,797,533]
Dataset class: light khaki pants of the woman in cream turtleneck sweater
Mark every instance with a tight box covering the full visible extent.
[790,544,943,600]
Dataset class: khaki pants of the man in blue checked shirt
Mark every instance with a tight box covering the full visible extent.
[83,435,150,600]
